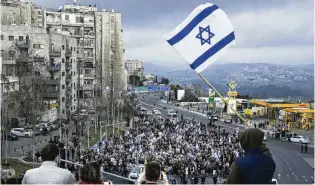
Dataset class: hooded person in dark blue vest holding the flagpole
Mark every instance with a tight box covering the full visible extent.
[227,128,276,184]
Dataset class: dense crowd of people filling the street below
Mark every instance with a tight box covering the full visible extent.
[66,117,244,184]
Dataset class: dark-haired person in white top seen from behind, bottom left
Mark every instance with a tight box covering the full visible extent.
[22,143,76,184]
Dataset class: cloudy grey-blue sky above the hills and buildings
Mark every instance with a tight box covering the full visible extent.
[33,0,314,67]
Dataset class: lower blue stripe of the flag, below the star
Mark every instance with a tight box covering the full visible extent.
[190,31,235,70]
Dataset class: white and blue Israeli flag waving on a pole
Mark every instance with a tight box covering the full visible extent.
[165,3,235,73]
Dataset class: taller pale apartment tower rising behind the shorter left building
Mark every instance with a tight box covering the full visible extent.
[44,5,127,108]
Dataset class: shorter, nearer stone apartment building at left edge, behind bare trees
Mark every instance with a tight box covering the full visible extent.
[1,25,77,121]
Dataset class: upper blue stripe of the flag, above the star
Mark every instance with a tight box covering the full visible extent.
[167,5,219,45]
